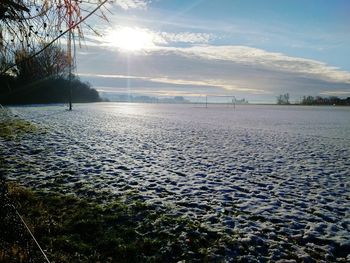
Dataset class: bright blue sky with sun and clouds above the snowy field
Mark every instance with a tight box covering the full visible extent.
[77,0,350,102]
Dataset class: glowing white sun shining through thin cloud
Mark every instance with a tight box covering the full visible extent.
[106,27,154,51]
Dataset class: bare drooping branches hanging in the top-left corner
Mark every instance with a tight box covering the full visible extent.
[0,0,107,75]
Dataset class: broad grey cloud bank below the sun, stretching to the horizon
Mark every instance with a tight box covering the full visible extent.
[78,45,350,102]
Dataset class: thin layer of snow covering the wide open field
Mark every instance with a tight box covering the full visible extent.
[0,103,350,262]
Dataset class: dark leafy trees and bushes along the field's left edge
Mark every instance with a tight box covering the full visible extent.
[0,43,101,104]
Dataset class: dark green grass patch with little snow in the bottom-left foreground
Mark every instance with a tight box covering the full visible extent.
[2,183,238,262]
